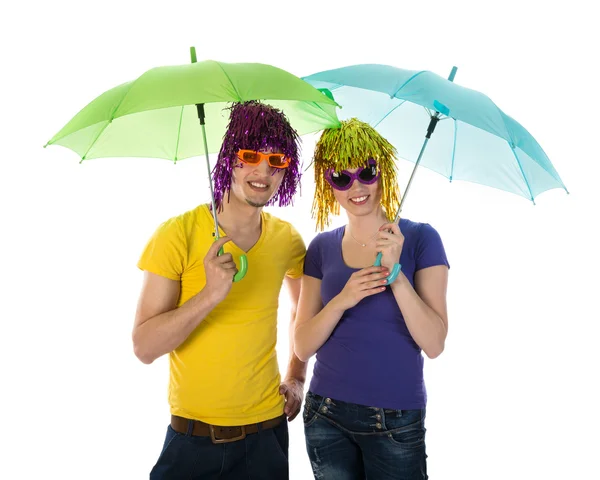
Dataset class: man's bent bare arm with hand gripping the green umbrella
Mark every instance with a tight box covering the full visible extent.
[132,237,236,364]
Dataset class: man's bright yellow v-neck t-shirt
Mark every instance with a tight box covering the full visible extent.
[138,205,306,426]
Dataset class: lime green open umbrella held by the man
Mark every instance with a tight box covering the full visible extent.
[45,47,340,281]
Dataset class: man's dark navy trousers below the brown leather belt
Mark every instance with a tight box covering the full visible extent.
[150,419,289,480]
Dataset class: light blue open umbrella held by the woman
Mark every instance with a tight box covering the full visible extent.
[303,64,568,281]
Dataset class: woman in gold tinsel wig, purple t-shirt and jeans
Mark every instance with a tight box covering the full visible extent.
[294,119,449,480]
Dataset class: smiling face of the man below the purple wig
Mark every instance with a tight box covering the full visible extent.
[231,149,286,208]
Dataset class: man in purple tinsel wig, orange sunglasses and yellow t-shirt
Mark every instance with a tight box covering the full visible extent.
[133,102,306,480]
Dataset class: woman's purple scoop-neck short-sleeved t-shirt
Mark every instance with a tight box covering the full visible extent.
[304,219,449,410]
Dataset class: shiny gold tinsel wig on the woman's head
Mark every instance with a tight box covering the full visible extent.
[312,118,400,231]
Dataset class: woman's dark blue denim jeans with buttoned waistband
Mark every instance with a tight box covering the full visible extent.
[303,392,428,480]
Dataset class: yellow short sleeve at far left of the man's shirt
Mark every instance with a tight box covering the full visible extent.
[137,218,187,280]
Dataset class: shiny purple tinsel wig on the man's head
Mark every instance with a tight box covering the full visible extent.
[212,100,301,211]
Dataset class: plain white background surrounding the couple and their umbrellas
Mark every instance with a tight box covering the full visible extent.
[0,0,600,480]
